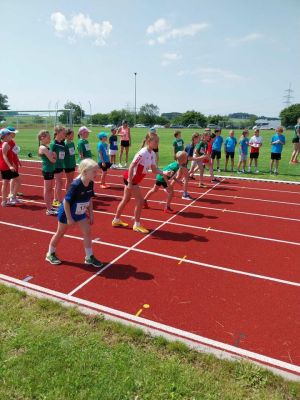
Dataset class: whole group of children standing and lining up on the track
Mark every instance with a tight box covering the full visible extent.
[0,124,292,268]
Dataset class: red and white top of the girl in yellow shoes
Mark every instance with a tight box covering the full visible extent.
[124,147,156,185]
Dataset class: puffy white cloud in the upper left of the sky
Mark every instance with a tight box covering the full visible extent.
[51,12,112,46]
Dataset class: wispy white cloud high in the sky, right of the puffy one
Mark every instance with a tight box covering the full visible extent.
[147,19,209,46]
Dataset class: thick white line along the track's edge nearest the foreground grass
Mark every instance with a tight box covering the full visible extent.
[0,274,300,375]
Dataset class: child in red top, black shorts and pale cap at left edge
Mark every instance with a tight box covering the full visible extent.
[0,128,20,207]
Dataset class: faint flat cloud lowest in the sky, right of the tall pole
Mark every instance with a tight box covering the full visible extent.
[177,67,246,84]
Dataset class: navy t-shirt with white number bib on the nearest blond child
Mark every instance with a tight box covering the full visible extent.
[58,177,95,220]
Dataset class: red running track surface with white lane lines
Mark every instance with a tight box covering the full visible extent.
[0,164,300,376]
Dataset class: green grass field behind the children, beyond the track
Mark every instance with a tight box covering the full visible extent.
[12,127,300,181]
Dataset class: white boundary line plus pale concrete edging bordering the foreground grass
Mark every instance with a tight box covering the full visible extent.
[0,274,300,381]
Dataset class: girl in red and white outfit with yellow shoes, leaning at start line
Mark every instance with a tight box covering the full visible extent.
[112,132,168,233]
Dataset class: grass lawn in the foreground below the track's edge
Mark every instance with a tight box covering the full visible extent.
[0,285,300,400]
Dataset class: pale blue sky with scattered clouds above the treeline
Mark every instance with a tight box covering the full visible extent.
[0,0,300,116]
